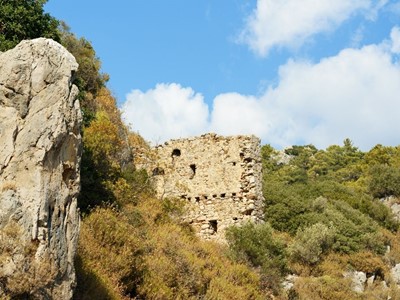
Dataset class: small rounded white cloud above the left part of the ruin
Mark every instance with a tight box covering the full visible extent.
[122,83,209,143]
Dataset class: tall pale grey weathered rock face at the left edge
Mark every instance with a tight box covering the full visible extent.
[0,38,81,299]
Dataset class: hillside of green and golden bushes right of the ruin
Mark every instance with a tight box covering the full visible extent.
[260,140,400,299]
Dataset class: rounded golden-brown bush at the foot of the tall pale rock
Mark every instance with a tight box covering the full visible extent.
[77,208,145,295]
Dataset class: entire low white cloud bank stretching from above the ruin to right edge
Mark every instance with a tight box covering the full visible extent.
[123,27,400,150]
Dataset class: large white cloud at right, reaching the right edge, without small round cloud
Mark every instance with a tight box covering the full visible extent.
[212,28,400,149]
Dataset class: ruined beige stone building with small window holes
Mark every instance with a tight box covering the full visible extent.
[151,133,263,241]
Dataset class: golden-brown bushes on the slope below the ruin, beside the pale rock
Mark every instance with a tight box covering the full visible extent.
[75,198,266,299]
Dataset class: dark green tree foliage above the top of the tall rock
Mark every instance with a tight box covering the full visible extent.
[0,0,60,51]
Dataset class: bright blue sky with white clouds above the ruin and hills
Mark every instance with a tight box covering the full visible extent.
[45,0,400,150]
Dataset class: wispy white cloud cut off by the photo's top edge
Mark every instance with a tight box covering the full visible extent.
[239,0,387,56]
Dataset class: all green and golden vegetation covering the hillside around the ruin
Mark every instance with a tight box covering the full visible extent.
[0,1,400,299]
